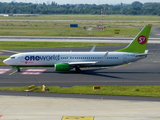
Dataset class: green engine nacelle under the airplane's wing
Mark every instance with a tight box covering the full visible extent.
[54,63,70,71]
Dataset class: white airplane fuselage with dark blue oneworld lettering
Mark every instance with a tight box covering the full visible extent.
[4,52,145,67]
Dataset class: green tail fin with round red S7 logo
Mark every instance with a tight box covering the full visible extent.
[114,25,152,53]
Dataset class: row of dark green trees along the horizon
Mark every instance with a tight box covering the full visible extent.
[0,1,160,15]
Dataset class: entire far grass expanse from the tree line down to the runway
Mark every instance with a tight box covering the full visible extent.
[0,15,160,37]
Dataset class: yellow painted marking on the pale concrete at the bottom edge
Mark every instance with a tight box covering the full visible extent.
[62,116,94,120]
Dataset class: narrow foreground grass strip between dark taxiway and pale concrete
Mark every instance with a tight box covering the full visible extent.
[0,86,160,97]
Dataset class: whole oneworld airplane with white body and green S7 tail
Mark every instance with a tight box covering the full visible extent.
[3,25,152,72]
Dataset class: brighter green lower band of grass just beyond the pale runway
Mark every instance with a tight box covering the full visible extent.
[0,27,139,37]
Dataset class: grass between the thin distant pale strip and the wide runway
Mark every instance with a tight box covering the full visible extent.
[0,21,139,37]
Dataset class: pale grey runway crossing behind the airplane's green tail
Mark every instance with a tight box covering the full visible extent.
[0,35,160,43]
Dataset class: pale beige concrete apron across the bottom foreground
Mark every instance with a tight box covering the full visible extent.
[0,96,160,120]
